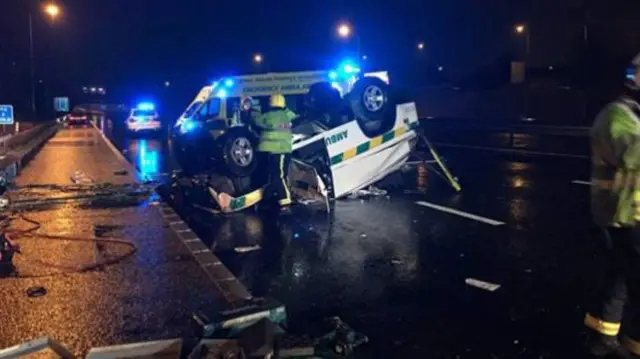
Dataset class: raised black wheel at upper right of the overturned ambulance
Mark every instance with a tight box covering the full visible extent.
[347,77,396,137]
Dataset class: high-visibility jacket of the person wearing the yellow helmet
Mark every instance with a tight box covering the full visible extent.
[255,109,296,153]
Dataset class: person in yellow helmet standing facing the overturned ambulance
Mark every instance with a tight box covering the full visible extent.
[255,94,296,211]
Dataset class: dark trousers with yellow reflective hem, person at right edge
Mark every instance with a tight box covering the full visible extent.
[585,227,640,355]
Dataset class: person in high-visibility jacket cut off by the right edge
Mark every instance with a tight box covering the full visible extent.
[584,55,640,358]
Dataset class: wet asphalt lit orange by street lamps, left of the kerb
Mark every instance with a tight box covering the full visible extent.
[0,129,219,355]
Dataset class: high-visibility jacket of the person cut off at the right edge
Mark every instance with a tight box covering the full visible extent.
[591,98,640,227]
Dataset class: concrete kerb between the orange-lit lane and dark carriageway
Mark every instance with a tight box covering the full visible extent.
[94,124,253,308]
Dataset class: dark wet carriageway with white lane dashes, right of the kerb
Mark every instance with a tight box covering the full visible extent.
[100,117,598,359]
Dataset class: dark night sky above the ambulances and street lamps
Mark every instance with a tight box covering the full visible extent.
[0,0,640,109]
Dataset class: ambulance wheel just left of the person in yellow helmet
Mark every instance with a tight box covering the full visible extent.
[222,129,258,177]
